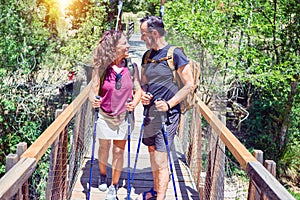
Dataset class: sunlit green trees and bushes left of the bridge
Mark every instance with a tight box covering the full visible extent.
[0,0,108,199]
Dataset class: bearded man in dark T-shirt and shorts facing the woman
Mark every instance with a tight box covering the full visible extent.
[138,16,194,200]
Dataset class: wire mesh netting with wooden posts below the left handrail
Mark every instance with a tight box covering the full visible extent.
[2,78,93,200]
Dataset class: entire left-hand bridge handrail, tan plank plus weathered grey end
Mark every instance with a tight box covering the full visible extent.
[0,83,91,199]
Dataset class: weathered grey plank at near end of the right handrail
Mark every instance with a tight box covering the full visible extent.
[246,161,295,200]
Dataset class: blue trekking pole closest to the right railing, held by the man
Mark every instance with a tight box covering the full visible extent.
[157,98,178,200]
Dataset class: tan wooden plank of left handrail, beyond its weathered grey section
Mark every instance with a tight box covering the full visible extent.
[22,83,91,162]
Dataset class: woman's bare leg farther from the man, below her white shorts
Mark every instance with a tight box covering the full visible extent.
[98,139,111,175]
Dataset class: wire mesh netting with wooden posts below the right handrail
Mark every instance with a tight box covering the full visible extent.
[179,105,249,199]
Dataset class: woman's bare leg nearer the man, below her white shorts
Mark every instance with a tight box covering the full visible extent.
[111,140,127,185]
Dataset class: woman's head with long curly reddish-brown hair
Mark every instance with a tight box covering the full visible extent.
[93,30,130,68]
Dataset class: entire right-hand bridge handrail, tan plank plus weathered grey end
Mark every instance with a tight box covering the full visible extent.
[196,97,295,200]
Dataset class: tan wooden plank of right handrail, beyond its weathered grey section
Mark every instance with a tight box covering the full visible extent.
[195,97,256,170]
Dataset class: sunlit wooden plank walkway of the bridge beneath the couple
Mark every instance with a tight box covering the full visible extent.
[71,35,200,200]
